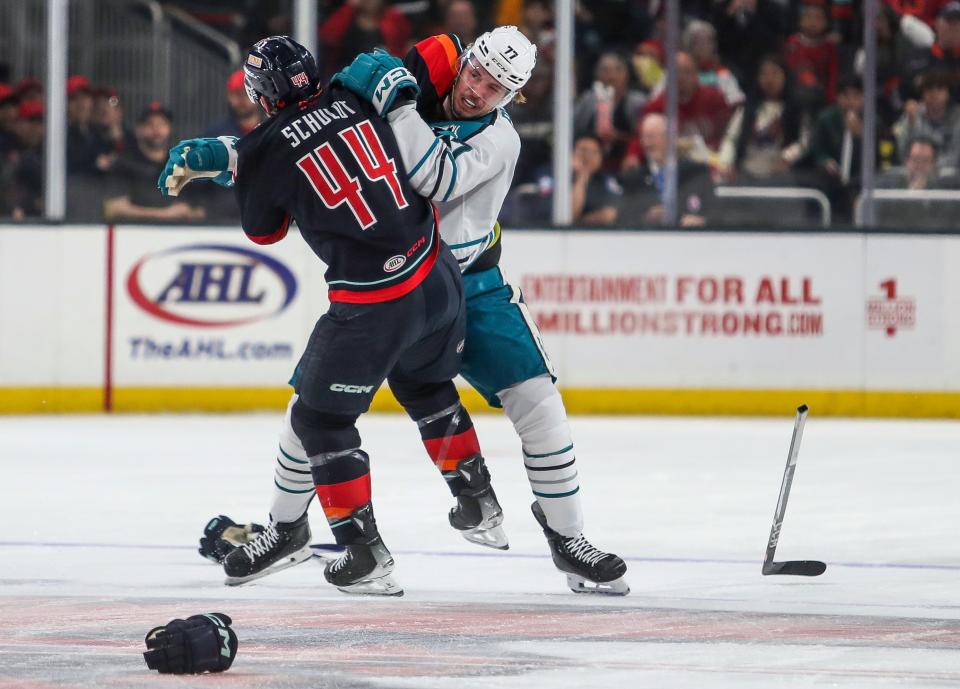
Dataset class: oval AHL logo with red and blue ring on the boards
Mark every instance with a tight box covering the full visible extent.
[127,244,297,328]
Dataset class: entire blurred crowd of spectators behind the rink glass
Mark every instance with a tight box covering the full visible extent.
[0,0,960,227]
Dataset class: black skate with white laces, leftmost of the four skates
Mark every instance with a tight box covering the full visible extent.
[223,514,313,586]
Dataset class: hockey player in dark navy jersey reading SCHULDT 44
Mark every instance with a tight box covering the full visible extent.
[159,36,495,595]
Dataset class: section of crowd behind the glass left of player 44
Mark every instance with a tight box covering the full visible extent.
[0,70,263,219]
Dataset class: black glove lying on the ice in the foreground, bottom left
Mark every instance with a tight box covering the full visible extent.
[143,612,237,675]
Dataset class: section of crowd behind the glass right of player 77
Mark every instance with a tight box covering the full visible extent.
[507,0,960,226]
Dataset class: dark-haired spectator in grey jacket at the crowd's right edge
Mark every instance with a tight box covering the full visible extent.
[893,70,960,168]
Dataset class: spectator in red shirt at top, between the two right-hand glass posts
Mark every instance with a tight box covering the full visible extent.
[783,0,840,112]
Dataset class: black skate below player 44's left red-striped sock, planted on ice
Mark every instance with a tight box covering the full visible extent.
[323,503,403,596]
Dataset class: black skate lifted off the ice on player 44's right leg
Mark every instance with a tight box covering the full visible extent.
[450,455,510,550]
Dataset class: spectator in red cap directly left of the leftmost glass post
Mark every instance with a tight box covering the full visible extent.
[6,100,44,220]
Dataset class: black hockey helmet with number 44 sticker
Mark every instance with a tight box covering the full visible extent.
[243,36,320,113]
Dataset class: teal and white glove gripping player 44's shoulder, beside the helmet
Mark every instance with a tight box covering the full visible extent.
[332,50,420,117]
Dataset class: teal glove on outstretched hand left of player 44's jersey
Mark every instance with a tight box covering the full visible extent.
[157,136,237,196]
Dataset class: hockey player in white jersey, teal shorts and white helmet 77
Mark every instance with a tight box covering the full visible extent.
[316,26,629,595]
